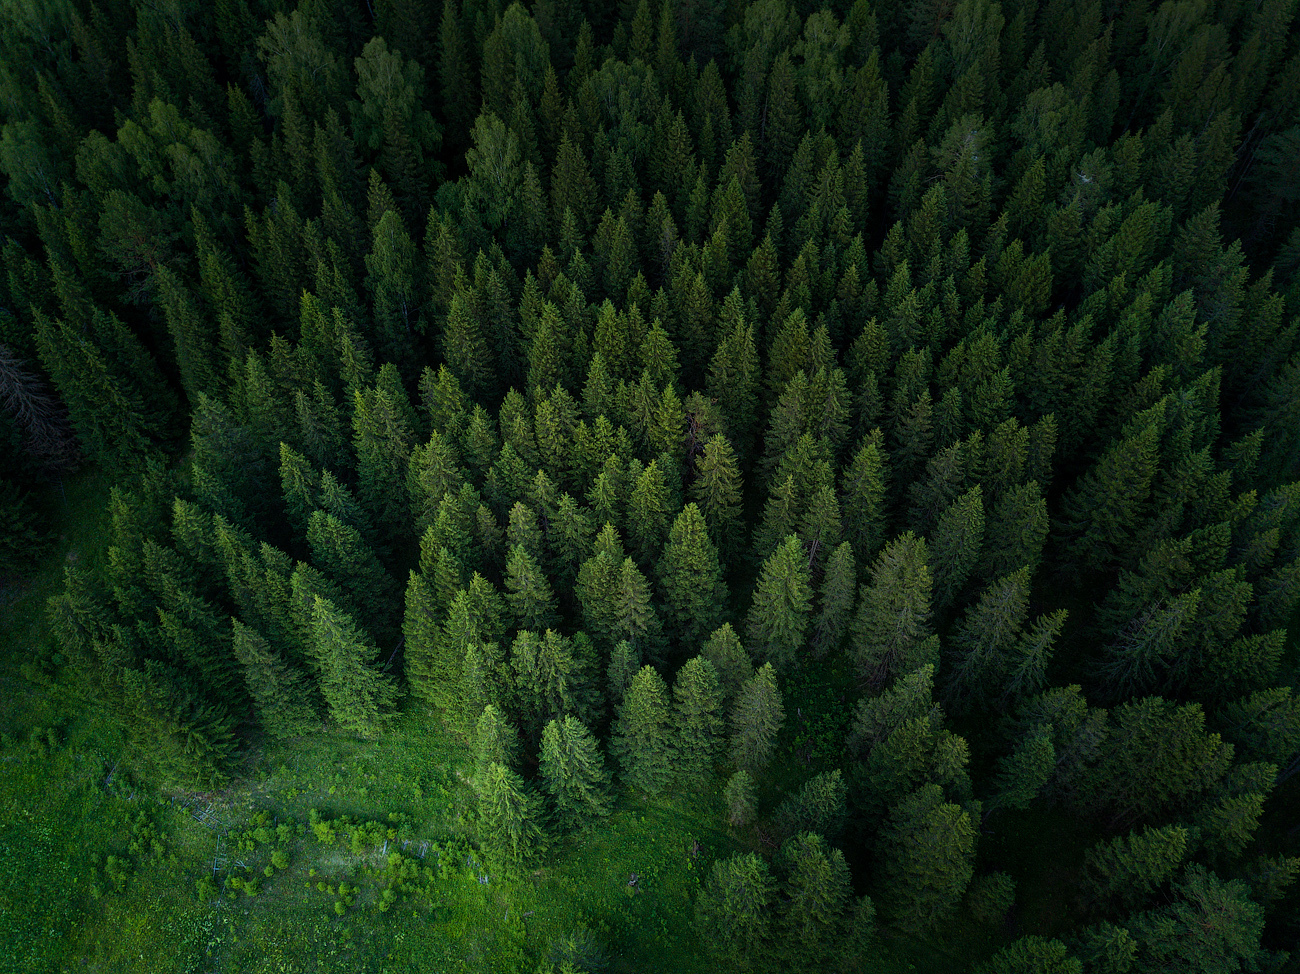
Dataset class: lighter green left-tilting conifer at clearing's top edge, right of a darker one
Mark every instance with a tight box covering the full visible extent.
[311,596,397,736]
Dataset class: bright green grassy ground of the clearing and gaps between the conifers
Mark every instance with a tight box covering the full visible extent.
[0,472,1067,974]
